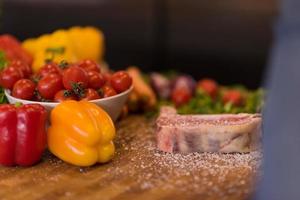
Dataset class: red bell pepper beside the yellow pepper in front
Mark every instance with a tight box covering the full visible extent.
[0,104,47,166]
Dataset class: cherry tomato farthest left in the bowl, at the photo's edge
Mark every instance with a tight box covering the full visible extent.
[0,67,23,90]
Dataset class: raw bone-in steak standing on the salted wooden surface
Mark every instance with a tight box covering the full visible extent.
[156,107,262,153]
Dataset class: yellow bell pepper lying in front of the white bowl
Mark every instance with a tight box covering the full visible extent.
[48,100,115,166]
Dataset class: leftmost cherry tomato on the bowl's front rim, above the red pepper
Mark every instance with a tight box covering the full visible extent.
[12,79,35,100]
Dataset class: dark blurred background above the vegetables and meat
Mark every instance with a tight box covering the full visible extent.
[0,0,277,88]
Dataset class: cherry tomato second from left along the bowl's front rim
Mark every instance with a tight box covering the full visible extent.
[37,74,63,100]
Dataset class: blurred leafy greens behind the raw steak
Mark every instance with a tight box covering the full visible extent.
[144,70,265,116]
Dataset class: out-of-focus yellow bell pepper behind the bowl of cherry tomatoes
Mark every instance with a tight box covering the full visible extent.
[22,27,104,72]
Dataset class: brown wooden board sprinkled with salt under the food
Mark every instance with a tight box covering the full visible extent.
[0,116,262,200]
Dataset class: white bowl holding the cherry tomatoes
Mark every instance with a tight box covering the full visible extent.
[4,86,133,121]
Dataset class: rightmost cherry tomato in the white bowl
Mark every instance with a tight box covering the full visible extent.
[110,71,132,93]
